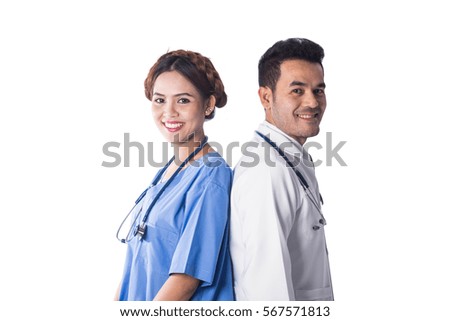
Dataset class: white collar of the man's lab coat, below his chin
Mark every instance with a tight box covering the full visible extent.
[258,120,310,163]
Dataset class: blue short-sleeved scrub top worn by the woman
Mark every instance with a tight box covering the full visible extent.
[119,152,234,301]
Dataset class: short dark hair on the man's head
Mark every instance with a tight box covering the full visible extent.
[258,38,325,90]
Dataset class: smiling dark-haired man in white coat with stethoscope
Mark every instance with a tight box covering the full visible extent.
[230,38,334,301]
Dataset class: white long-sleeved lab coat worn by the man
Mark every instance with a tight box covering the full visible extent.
[230,122,333,301]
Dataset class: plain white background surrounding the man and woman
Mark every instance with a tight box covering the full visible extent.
[0,0,450,320]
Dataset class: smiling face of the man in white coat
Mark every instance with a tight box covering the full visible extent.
[259,59,327,145]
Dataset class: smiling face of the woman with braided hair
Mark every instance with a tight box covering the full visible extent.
[152,71,209,144]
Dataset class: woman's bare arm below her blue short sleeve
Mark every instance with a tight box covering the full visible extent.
[154,273,200,301]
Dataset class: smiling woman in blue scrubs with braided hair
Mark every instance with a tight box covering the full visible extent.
[116,50,234,301]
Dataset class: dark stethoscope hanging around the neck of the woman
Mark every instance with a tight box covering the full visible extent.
[116,136,208,243]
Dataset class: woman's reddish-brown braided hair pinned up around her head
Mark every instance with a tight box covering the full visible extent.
[144,50,227,119]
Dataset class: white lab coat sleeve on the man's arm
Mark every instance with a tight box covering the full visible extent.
[230,165,298,301]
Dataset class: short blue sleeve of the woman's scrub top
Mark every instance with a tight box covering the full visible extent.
[170,170,231,286]
